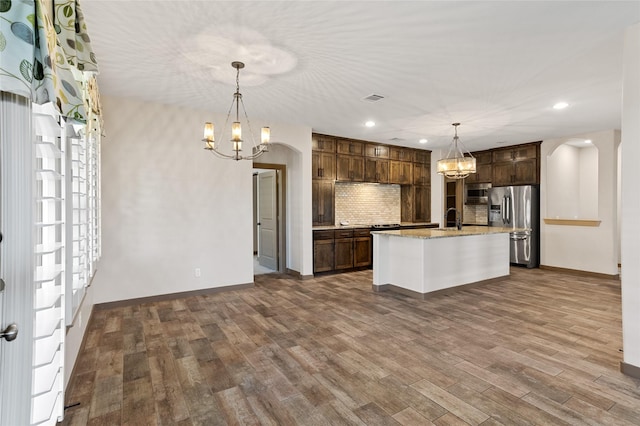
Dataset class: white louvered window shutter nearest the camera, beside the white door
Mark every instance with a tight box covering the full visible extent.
[31,105,67,425]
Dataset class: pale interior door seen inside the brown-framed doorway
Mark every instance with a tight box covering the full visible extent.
[258,170,278,271]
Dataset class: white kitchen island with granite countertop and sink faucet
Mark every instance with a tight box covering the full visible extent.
[372,226,513,298]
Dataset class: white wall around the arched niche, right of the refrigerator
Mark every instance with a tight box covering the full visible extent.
[540,130,620,275]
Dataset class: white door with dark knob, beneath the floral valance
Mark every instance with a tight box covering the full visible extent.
[0,92,36,425]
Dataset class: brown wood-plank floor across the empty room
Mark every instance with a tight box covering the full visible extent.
[64,268,640,425]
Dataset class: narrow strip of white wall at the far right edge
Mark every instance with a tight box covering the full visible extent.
[622,24,640,368]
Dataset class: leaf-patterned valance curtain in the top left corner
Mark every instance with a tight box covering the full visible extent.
[0,0,100,123]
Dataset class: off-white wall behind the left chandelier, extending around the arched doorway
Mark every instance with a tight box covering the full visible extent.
[94,97,312,303]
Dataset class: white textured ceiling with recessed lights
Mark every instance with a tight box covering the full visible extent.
[82,0,640,150]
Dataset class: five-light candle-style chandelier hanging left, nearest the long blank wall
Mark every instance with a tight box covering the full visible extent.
[202,61,271,161]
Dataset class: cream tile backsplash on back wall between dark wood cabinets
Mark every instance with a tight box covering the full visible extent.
[335,182,400,225]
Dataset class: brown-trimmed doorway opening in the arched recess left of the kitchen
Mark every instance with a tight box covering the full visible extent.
[253,163,286,275]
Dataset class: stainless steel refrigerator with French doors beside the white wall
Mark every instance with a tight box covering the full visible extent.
[487,185,540,268]
